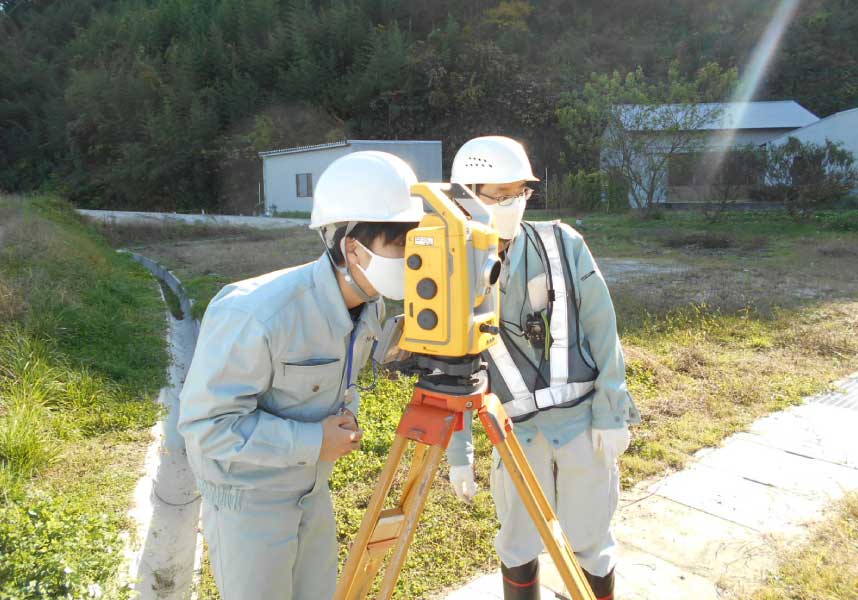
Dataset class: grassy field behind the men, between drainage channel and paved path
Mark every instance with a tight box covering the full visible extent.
[100,211,858,598]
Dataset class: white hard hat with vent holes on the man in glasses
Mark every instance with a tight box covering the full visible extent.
[450,135,539,185]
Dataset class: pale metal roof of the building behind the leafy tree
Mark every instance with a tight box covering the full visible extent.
[615,100,819,131]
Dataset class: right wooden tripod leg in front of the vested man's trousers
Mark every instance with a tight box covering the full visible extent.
[479,394,596,600]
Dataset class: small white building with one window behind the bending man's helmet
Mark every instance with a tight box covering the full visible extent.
[259,140,441,214]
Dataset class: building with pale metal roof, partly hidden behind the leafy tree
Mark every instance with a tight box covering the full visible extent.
[601,100,819,206]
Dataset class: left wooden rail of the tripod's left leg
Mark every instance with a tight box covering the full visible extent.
[334,435,408,600]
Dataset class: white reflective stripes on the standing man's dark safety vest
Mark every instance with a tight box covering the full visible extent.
[488,222,595,418]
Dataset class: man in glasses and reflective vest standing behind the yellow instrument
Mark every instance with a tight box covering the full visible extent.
[448,136,640,600]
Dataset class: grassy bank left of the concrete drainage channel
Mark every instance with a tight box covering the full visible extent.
[0,196,167,600]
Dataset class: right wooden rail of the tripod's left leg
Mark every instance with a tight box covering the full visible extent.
[376,445,445,600]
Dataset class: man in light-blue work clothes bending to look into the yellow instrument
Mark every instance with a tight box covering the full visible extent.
[179,152,423,600]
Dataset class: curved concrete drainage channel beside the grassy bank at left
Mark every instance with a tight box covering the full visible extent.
[121,250,202,600]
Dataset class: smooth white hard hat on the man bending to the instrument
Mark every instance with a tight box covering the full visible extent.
[310,150,424,229]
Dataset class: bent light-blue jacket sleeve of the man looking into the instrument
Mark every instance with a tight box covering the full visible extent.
[178,307,322,467]
